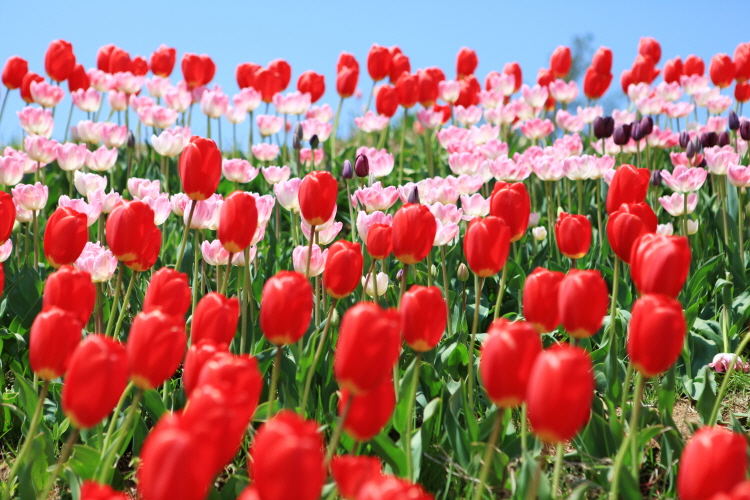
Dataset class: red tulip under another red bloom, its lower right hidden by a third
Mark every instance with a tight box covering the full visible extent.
[607,203,657,264]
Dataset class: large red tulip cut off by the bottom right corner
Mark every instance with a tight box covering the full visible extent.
[677,427,747,500]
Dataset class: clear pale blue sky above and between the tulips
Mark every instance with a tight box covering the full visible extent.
[0,0,750,144]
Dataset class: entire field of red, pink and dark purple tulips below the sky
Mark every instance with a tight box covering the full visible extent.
[0,38,750,500]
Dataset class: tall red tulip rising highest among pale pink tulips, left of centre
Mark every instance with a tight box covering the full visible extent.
[179,135,221,201]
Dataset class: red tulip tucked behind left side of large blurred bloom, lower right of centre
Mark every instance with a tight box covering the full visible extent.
[479,319,542,408]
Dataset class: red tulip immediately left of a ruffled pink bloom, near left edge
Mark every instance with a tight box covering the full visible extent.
[44,207,88,268]
